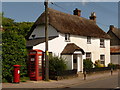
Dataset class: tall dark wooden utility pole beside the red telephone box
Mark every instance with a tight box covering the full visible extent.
[44,0,49,81]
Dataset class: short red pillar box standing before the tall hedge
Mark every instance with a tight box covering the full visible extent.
[13,65,20,83]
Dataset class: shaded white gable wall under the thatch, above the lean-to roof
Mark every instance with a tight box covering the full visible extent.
[29,25,58,39]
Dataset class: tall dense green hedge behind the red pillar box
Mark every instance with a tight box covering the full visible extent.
[2,31,27,82]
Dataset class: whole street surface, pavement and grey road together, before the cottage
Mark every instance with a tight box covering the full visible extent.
[2,71,118,90]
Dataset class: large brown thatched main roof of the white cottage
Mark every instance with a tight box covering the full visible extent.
[27,8,110,39]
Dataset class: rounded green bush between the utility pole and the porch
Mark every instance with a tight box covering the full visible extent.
[49,56,67,72]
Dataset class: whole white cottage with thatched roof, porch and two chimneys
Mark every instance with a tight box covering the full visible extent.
[26,8,110,72]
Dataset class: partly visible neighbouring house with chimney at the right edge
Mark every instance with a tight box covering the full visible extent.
[107,25,120,64]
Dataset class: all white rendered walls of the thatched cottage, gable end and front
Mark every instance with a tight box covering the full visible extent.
[31,26,110,66]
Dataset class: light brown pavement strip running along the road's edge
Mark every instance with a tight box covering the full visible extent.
[2,70,120,89]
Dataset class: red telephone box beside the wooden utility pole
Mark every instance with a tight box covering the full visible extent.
[29,49,44,81]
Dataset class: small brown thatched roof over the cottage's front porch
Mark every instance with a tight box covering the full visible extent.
[61,43,85,55]
